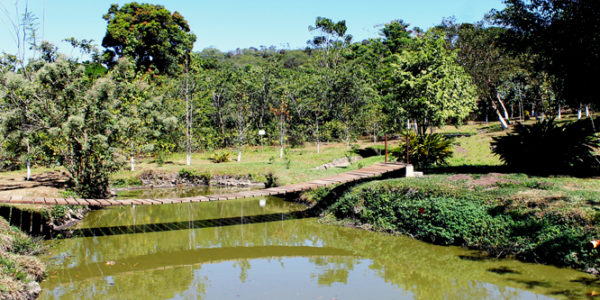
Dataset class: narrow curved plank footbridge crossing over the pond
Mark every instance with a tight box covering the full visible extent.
[0,163,412,206]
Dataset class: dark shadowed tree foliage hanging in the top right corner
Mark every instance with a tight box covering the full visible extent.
[493,0,600,111]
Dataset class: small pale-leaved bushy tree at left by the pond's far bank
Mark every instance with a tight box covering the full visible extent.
[0,59,121,198]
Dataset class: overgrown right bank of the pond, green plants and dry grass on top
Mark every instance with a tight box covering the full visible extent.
[308,174,600,273]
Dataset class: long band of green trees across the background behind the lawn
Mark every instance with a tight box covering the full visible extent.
[0,0,600,197]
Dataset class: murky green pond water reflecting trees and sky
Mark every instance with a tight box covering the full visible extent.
[41,191,600,300]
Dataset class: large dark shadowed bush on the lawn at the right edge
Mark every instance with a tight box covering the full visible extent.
[492,119,600,173]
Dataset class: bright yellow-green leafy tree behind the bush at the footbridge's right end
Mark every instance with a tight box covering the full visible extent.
[385,29,476,134]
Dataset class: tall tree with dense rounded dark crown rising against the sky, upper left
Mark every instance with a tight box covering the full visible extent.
[102,2,196,75]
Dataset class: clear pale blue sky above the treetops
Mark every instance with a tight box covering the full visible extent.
[0,0,504,54]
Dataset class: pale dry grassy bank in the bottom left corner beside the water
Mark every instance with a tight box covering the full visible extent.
[0,218,45,299]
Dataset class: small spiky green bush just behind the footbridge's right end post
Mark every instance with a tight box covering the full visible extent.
[390,132,452,169]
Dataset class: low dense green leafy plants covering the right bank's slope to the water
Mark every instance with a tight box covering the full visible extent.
[320,187,600,269]
